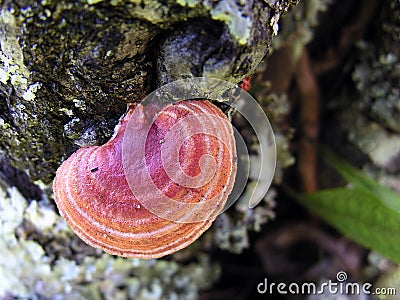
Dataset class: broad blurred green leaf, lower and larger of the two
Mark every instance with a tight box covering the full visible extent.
[297,188,400,263]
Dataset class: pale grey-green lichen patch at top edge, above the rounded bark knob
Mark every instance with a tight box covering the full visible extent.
[210,0,252,45]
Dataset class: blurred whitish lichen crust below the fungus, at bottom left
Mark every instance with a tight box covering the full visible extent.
[0,182,220,300]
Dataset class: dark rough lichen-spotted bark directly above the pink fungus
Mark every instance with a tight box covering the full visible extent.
[0,0,291,183]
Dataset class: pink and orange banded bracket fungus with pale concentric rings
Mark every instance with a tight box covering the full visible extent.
[53,100,236,259]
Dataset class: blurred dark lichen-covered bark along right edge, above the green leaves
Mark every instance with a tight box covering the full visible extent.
[341,2,400,171]
